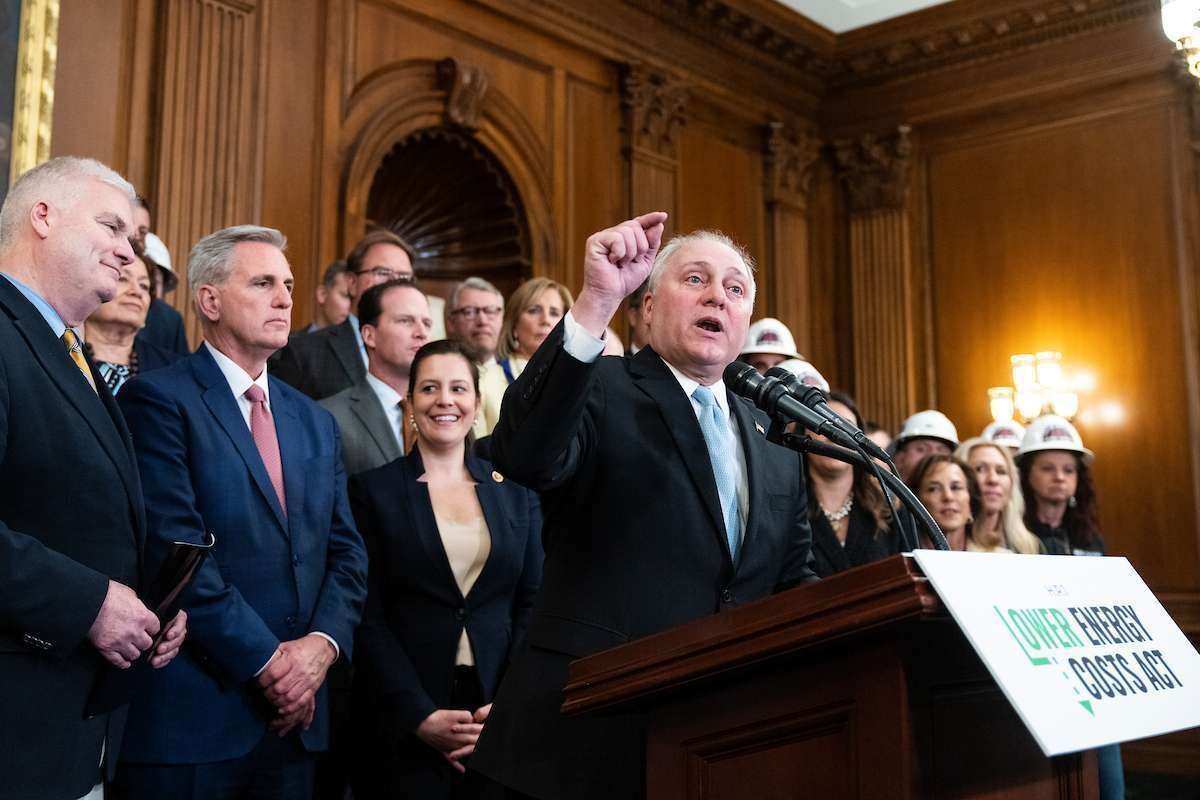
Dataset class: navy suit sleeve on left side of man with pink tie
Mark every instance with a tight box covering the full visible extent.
[119,380,280,684]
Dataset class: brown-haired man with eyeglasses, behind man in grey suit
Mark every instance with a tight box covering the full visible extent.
[270,229,444,399]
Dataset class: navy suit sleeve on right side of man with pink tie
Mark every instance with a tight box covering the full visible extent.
[310,422,367,658]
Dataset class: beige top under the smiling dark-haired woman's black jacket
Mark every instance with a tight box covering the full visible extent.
[430,483,492,667]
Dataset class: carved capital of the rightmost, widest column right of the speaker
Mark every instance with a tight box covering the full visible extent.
[834,125,912,213]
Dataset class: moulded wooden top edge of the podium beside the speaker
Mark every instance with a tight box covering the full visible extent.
[563,555,941,714]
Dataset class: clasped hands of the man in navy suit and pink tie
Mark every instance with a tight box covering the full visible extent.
[258,633,337,736]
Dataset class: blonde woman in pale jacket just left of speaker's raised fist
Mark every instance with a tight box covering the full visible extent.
[474,278,574,437]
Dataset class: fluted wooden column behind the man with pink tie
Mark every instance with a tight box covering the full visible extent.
[154,0,268,344]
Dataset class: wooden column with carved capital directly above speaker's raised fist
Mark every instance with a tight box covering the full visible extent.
[622,64,688,236]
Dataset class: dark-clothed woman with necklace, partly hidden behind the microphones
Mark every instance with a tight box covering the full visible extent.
[806,392,900,578]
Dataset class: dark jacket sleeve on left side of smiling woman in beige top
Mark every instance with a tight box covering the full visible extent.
[349,476,437,747]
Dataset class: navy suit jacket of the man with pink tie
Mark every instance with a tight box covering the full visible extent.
[120,347,366,764]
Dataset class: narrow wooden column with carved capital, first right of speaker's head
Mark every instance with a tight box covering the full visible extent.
[757,122,821,356]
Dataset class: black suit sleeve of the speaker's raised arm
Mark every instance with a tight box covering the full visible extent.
[492,320,604,492]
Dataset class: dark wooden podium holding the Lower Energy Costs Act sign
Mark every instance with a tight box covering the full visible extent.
[563,555,1098,800]
